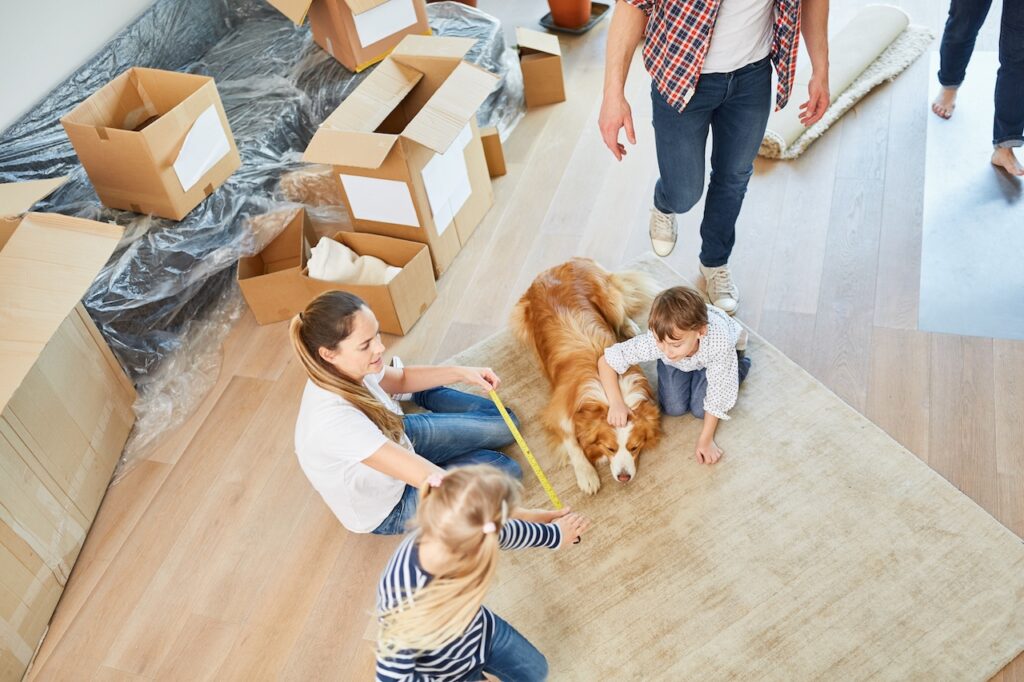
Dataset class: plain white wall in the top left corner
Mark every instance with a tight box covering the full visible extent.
[0,0,153,130]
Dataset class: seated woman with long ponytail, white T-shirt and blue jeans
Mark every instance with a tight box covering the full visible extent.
[290,291,522,535]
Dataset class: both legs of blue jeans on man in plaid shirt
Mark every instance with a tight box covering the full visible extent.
[651,57,771,267]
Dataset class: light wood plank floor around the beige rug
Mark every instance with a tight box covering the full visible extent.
[25,0,1024,682]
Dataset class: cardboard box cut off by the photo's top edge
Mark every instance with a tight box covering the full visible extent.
[268,0,430,72]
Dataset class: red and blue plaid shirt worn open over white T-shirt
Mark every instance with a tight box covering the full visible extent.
[624,0,800,112]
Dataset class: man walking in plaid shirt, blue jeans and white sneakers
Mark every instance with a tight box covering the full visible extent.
[599,0,828,314]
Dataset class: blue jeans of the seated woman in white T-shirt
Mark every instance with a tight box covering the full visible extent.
[374,386,522,536]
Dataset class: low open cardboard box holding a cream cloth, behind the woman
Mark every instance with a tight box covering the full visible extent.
[238,209,437,335]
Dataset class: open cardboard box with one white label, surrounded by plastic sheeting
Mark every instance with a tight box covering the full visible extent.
[60,67,242,220]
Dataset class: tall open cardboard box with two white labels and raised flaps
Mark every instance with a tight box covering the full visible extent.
[303,36,498,275]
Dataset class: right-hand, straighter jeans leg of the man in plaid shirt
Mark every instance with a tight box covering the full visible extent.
[700,58,772,267]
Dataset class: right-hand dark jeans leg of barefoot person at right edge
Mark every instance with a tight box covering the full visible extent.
[992,0,1024,146]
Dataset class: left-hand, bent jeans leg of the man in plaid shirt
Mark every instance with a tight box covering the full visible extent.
[650,80,724,213]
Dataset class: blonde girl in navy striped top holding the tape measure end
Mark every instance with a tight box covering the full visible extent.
[377,465,590,682]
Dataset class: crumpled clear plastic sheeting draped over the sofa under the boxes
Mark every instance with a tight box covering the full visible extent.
[0,0,524,466]
